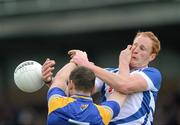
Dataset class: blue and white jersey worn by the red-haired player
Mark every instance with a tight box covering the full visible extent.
[96,67,162,125]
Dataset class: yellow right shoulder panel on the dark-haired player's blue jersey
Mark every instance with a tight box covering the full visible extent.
[95,105,112,125]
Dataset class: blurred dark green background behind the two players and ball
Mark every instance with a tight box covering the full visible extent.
[0,0,180,125]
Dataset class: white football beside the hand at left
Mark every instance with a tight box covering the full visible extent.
[14,60,45,93]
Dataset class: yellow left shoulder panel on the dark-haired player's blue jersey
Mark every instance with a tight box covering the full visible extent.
[48,96,75,114]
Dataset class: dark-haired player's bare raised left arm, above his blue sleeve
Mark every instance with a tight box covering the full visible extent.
[51,62,76,90]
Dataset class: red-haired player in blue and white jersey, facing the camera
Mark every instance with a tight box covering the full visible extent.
[69,32,162,125]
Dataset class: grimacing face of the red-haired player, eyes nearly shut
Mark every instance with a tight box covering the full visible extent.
[130,35,154,68]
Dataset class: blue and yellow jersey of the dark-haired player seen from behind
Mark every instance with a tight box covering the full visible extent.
[47,87,120,125]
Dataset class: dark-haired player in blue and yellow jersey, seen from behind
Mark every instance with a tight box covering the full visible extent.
[43,60,126,125]
